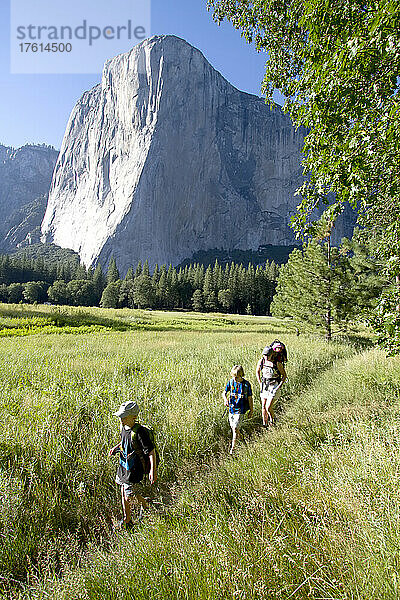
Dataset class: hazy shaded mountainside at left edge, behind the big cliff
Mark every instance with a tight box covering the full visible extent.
[0,145,58,252]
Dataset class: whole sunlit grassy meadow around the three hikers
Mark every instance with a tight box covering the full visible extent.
[0,305,400,600]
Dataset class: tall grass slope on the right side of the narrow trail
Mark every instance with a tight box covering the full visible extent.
[24,351,400,600]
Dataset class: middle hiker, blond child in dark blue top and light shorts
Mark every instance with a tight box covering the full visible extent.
[222,365,253,454]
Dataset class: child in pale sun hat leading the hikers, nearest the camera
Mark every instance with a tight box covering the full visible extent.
[109,401,157,528]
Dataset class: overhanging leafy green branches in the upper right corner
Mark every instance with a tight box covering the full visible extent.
[209,0,400,349]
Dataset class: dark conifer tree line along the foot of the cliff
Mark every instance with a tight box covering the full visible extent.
[0,255,279,314]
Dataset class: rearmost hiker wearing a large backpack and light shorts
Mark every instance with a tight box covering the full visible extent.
[256,340,287,427]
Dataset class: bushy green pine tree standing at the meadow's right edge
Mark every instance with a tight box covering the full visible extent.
[271,240,382,339]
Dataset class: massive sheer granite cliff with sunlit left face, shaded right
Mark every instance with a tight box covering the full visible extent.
[42,36,352,272]
